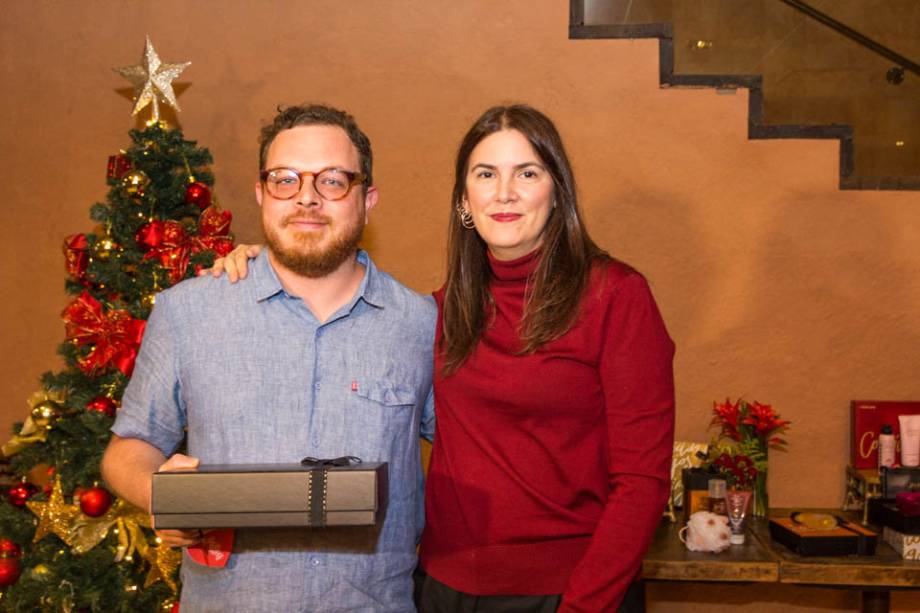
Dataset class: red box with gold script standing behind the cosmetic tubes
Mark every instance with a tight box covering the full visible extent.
[850,400,920,468]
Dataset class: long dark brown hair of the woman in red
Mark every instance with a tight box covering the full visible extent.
[438,104,607,376]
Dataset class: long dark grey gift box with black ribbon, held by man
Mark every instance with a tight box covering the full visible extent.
[151,462,388,529]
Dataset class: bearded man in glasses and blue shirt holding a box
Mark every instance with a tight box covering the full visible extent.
[102,105,436,613]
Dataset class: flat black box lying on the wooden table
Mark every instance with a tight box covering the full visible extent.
[770,517,878,556]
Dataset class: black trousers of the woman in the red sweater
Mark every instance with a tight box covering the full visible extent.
[415,569,645,613]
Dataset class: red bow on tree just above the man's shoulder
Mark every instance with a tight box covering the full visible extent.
[134,205,233,283]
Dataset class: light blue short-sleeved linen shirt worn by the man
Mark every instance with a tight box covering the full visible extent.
[112,251,436,613]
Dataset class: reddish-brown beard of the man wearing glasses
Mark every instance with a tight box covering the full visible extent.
[262,215,364,279]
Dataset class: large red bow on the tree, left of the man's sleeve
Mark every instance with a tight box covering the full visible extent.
[61,291,147,377]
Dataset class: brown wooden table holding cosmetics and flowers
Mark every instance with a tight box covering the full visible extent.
[642,509,920,613]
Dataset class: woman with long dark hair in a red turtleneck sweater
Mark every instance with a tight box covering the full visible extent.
[420,105,674,613]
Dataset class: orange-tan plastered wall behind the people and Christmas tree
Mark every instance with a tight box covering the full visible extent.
[0,0,920,613]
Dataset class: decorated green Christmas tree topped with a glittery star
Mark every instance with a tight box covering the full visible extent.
[0,39,233,612]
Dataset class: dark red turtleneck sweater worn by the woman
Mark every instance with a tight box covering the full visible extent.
[420,253,674,613]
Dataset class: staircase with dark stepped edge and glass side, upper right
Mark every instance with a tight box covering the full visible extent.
[569,0,920,190]
